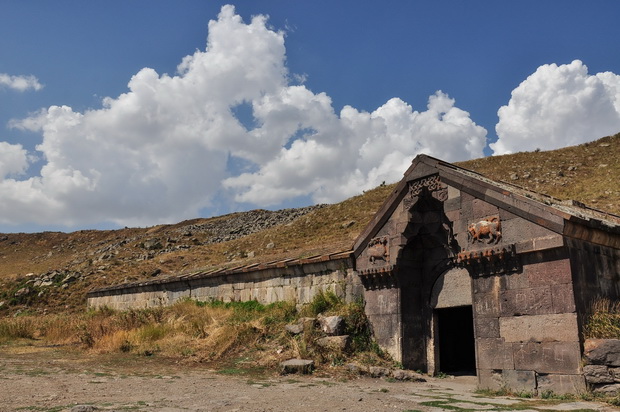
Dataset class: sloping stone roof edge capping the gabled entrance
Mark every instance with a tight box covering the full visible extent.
[353,154,620,257]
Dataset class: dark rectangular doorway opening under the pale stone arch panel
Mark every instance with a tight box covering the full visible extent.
[436,306,476,375]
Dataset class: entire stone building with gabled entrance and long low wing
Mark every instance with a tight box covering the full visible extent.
[88,155,620,393]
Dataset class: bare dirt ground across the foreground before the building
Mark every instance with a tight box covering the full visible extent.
[0,346,617,412]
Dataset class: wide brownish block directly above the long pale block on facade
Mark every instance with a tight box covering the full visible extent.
[500,287,553,316]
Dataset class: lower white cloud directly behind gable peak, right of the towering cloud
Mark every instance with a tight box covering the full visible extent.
[224,91,486,206]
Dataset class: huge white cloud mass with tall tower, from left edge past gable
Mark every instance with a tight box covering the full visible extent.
[0,6,486,229]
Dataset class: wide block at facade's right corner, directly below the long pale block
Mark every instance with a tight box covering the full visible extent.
[512,342,581,374]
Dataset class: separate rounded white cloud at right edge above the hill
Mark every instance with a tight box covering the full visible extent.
[490,60,620,154]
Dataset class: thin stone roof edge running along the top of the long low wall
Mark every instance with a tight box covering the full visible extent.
[86,250,353,297]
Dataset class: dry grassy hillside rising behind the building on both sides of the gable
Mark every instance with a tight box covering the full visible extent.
[0,134,620,316]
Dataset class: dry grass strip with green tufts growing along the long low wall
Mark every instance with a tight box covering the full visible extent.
[0,293,390,374]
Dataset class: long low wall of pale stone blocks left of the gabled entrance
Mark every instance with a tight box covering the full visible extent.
[88,257,364,310]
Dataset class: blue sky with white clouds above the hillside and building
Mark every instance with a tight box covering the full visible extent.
[0,0,620,232]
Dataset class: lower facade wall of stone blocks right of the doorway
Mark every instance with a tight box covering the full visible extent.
[473,225,585,393]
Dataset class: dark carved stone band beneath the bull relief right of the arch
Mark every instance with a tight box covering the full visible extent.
[454,245,522,276]
